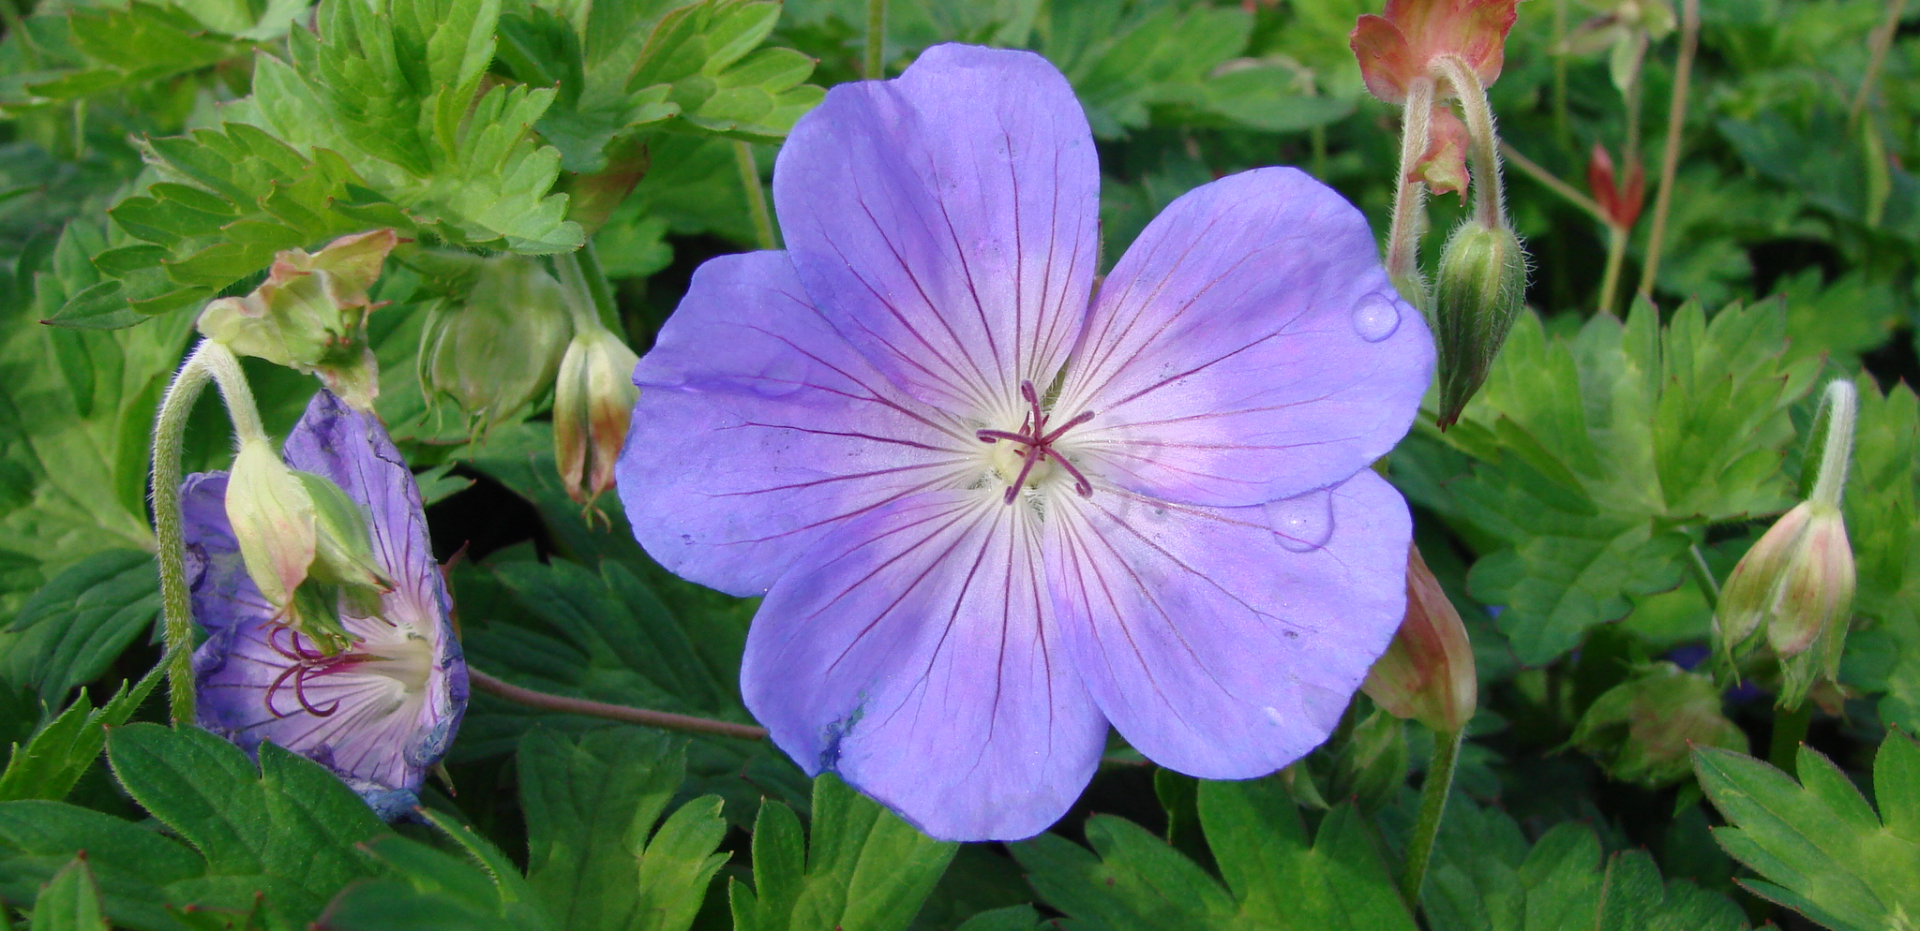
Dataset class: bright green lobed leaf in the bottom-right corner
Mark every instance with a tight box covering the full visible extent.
[1693,731,1920,931]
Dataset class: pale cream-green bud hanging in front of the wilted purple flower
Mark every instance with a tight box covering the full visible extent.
[227,438,319,610]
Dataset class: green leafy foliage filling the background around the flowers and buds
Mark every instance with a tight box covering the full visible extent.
[0,0,1920,931]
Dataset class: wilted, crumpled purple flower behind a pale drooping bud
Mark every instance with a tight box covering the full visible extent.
[180,390,467,820]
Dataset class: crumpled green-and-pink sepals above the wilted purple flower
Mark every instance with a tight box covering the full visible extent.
[198,230,401,411]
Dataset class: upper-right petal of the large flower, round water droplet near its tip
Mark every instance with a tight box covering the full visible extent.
[1054,169,1432,507]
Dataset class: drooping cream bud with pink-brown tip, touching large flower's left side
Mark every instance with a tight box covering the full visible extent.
[553,326,639,505]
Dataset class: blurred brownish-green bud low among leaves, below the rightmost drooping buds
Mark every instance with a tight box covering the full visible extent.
[1572,662,1747,789]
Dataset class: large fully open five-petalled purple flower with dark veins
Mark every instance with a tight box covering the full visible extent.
[618,46,1432,839]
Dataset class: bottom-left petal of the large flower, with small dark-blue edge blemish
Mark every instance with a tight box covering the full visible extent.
[741,489,1106,841]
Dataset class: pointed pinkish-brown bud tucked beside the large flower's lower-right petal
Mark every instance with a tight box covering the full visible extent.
[1361,547,1480,733]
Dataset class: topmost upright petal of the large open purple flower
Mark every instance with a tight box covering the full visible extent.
[774,44,1100,411]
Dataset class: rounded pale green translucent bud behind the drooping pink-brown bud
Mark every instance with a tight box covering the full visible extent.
[419,255,572,426]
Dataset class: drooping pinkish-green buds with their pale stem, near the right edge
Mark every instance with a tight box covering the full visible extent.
[1715,380,1857,708]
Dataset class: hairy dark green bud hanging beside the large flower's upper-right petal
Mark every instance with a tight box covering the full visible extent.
[1434,221,1526,426]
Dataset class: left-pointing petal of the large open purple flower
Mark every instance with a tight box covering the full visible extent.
[616,251,979,595]
